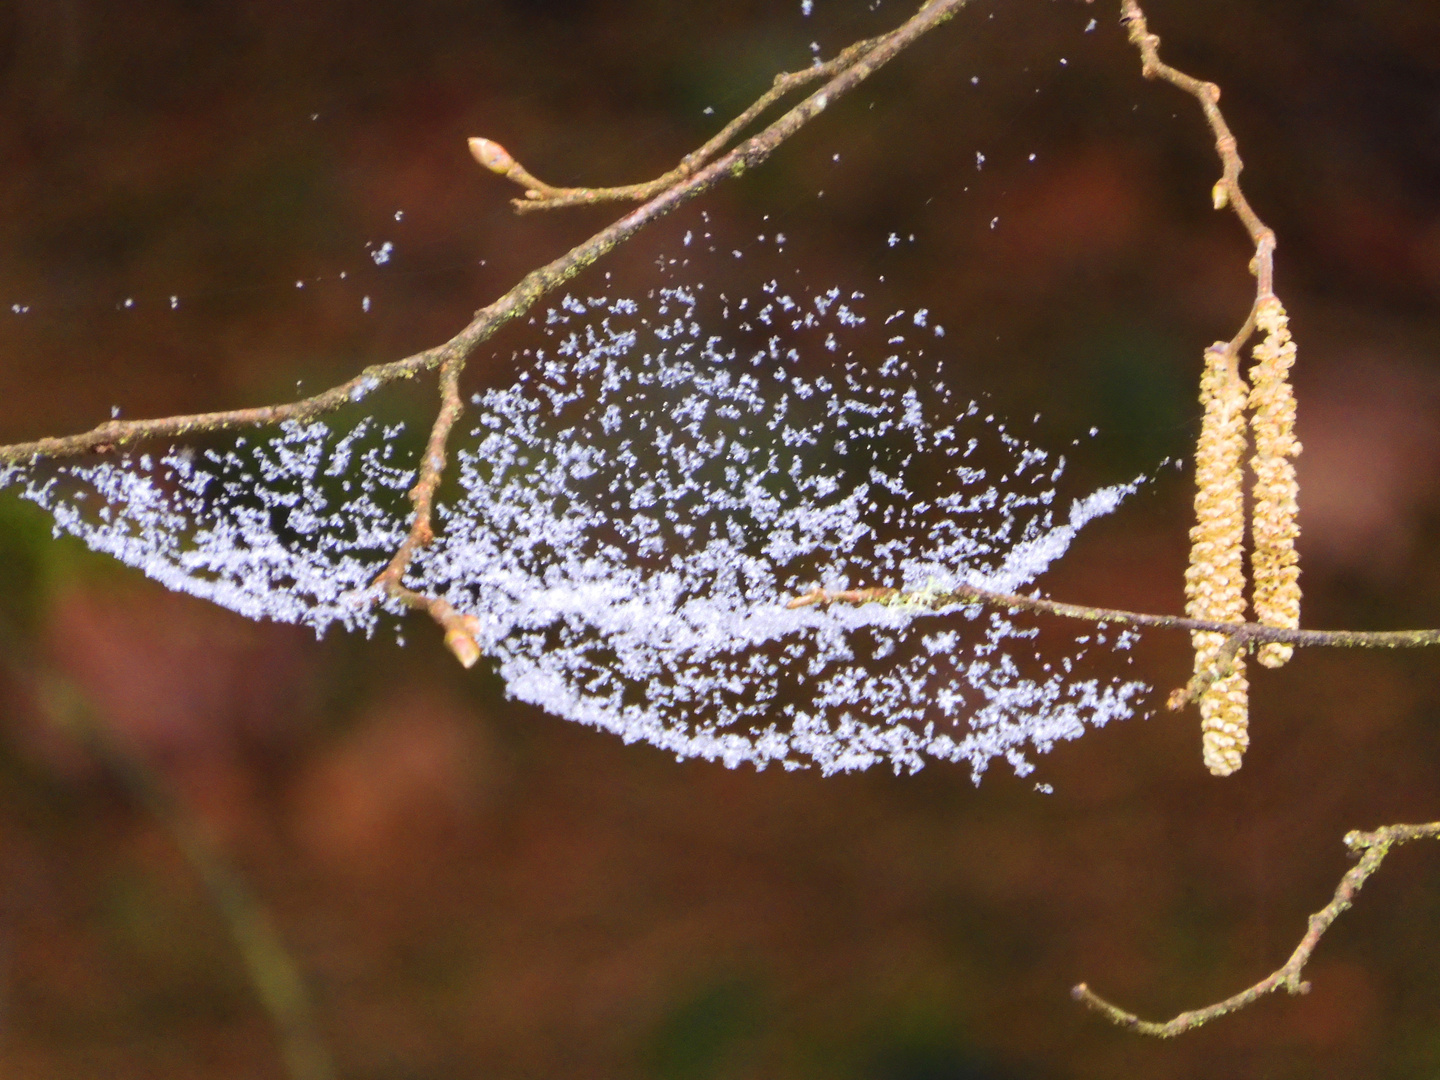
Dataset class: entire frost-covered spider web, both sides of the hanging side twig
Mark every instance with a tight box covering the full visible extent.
[0,282,1145,778]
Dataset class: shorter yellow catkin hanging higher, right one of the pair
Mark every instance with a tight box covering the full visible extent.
[1250,297,1300,668]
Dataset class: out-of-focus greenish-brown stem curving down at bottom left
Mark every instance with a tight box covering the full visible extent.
[43,678,336,1080]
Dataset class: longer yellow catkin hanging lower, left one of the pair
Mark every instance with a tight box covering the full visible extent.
[1185,344,1250,776]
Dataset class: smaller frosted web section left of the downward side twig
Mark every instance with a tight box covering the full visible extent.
[0,418,415,631]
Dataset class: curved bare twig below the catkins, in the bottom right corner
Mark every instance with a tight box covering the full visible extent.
[1070,821,1440,1038]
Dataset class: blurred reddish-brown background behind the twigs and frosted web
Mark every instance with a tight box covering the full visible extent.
[0,0,1440,1080]
